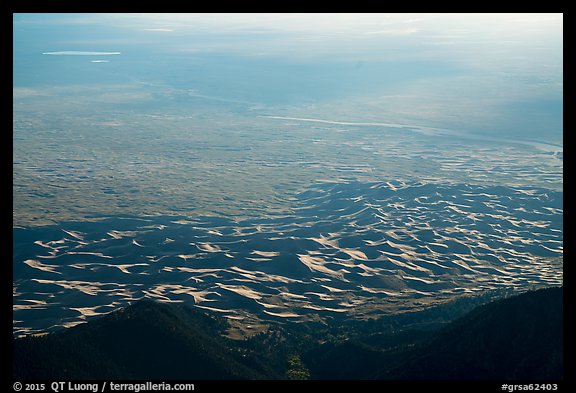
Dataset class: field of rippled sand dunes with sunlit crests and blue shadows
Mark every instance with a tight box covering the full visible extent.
[13,182,563,334]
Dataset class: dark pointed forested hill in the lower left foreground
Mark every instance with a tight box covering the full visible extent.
[14,301,276,380]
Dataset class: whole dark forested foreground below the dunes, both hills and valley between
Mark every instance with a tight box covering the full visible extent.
[13,287,564,381]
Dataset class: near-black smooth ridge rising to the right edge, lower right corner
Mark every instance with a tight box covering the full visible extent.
[379,288,563,380]
